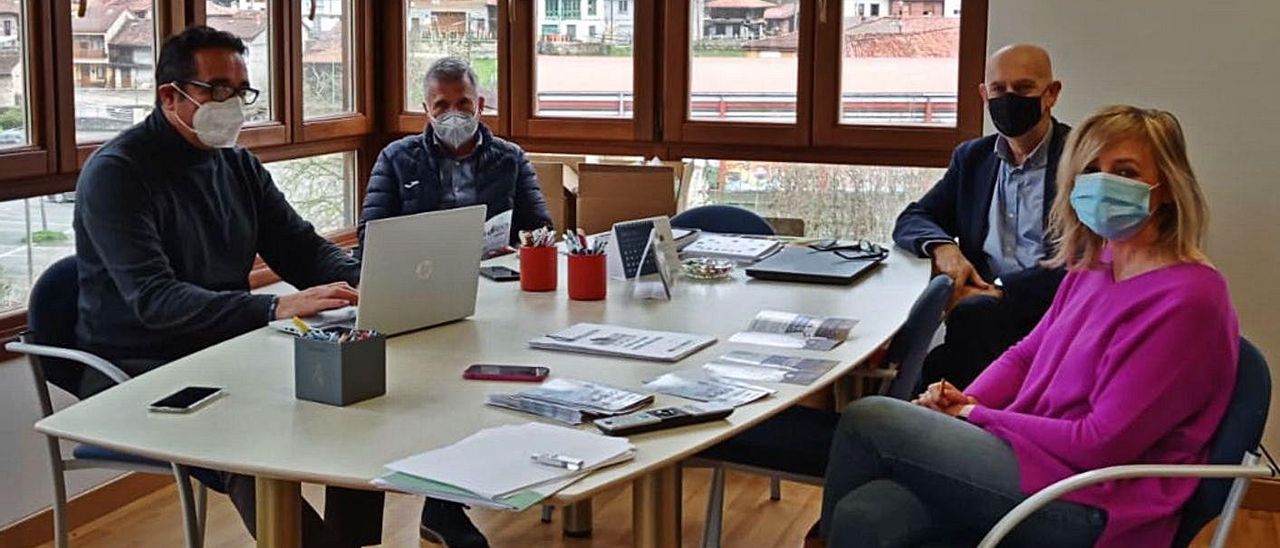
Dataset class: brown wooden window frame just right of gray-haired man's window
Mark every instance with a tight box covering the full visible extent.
[507,1,662,143]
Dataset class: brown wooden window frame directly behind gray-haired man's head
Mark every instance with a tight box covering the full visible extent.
[380,0,511,136]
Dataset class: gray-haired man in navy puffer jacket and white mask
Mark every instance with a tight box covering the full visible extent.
[356,58,552,256]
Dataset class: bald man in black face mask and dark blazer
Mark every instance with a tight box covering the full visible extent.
[893,45,1071,388]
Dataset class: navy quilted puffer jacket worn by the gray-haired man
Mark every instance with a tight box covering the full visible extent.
[356,124,552,257]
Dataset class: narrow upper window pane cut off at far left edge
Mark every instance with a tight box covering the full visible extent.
[0,0,31,149]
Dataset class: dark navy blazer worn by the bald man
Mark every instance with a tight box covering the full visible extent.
[893,119,1071,312]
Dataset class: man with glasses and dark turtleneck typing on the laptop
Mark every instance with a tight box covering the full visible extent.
[74,27,383,548]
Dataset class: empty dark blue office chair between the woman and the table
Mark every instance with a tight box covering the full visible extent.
[687,274,952,548]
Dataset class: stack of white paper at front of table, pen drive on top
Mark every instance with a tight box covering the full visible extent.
[374,423,635,511]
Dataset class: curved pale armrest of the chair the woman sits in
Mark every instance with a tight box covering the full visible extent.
[978,465,1272,548]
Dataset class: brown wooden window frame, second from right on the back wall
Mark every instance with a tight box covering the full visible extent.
[664,0,820,147]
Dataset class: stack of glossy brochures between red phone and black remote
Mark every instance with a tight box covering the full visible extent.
[485,378,653,424]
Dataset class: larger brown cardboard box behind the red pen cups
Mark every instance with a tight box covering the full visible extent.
[577,164,676,234]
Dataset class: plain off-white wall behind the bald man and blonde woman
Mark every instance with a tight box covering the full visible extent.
[988,0,1280,448]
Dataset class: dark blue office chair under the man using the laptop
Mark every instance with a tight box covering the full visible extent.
[5,256,207,548]
